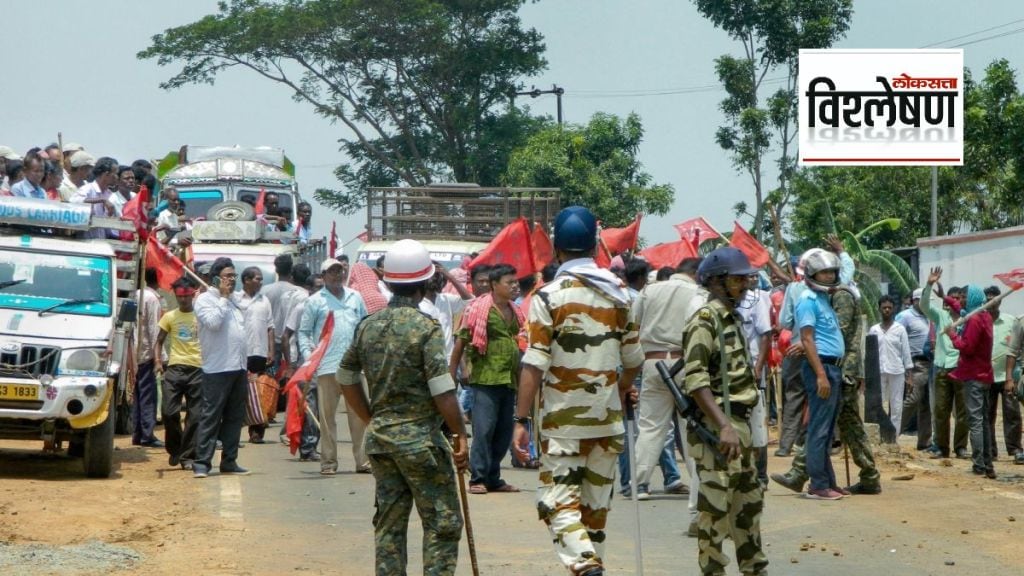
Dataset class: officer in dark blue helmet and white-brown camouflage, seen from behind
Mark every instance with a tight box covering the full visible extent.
[513,206,643,576]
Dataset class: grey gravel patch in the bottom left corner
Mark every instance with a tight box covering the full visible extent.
[0,541,142,576]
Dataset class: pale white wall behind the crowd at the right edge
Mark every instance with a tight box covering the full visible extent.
[918,227,1024,317]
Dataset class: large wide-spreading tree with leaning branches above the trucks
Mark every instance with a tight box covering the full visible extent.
[138,0,547,213]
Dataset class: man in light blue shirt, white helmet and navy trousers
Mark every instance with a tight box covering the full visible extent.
[794,250,849,500]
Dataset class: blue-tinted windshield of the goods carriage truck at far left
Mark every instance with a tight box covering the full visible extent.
[0,250,113,316]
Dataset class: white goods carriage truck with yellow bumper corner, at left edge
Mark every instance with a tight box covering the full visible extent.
[0,197,139,478]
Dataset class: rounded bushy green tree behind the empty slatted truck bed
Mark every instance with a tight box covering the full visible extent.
[505,113,675,228]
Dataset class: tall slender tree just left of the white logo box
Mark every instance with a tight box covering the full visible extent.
[693,0,853,237]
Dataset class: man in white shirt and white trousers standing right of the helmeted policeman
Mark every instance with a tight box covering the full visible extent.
[867,295,913,436]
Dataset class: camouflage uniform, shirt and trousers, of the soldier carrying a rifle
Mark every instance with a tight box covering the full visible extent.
[683,299,768,576]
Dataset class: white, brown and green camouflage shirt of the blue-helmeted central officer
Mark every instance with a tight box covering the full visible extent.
[522,266,643,439]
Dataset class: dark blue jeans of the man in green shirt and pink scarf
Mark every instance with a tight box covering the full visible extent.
[469,384,515,490]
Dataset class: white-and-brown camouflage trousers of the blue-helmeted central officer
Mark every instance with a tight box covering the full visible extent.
[537,436,624,575]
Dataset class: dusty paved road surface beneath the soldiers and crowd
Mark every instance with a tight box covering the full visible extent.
[196,415,1024,576]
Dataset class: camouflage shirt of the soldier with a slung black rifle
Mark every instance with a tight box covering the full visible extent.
[683,299,758,409]
